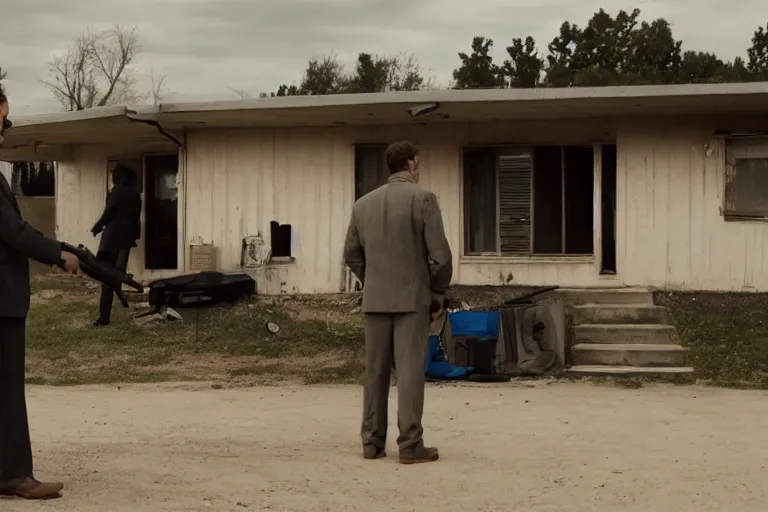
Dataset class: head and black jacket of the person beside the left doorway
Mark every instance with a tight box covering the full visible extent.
[92,166,141,251]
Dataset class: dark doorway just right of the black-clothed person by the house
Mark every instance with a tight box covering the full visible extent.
[144,154,179,270]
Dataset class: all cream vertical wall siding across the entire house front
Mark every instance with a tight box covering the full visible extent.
[56,115,768,293]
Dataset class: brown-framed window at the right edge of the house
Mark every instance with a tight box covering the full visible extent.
[723,139,768,220]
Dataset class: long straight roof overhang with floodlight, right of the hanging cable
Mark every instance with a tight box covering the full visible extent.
[147,83,768,128]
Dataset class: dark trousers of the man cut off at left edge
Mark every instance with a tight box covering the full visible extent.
[0,318,32,487]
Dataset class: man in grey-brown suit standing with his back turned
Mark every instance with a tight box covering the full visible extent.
[344,142,453,464]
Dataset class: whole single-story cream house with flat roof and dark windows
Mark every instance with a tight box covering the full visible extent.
[0,83,768,294]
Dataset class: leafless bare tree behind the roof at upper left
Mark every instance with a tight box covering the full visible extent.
[43,26,142,110]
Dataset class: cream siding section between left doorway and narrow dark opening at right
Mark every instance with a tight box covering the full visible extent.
[185,121,614,293]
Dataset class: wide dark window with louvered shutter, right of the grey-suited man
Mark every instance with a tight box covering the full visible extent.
[463,146,594,256]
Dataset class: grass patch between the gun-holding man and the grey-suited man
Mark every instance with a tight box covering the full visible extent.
[27,290,364,385]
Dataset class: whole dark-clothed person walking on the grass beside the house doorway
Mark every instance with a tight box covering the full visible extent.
[91,164,141,327]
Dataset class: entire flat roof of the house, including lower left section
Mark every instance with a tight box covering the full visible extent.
[0,82,768,159]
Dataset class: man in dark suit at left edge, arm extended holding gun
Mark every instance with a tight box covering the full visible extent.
[0,86,80,499]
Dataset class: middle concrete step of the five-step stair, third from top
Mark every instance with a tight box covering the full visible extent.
[573,324,677,345]
